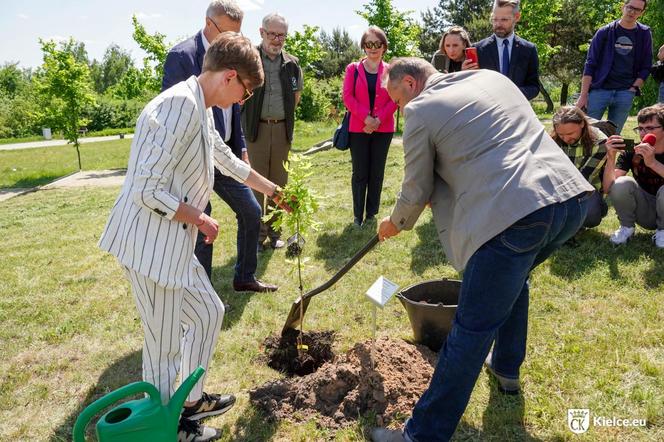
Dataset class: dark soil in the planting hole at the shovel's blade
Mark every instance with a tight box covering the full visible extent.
[263,329,334,376]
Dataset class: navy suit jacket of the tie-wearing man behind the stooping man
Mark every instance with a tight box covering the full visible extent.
[474,34,539,100]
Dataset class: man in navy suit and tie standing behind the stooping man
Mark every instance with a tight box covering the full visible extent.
[462,0,539,100]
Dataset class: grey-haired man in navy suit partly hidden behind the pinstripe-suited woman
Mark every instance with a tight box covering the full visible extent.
[162,0,278,292]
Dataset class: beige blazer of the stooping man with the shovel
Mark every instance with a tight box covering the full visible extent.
[391,70,593,270]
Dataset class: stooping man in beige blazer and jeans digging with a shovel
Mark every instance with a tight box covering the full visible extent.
[372,58,593,442]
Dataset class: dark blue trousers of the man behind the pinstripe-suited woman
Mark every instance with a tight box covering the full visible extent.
[194,169,261,282]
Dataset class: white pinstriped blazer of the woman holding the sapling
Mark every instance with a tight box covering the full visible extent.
[99,76,251,288]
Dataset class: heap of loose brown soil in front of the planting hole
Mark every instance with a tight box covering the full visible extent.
[249,338,437,429]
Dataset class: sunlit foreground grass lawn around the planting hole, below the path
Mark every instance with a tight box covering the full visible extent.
[0,134,664,441]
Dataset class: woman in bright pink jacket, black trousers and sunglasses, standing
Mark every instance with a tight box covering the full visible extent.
[343,26,397,226]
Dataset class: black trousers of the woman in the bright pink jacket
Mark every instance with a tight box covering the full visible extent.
[350,132,394,221]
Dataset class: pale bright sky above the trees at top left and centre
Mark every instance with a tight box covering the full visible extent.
[0,0,438,68]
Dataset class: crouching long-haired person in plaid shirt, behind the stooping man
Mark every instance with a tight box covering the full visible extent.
[551,106,609,228]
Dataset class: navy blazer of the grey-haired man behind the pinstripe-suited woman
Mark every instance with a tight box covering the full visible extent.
[161,31,247,158]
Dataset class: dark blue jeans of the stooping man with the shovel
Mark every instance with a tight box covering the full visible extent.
[404,193,591,442]
